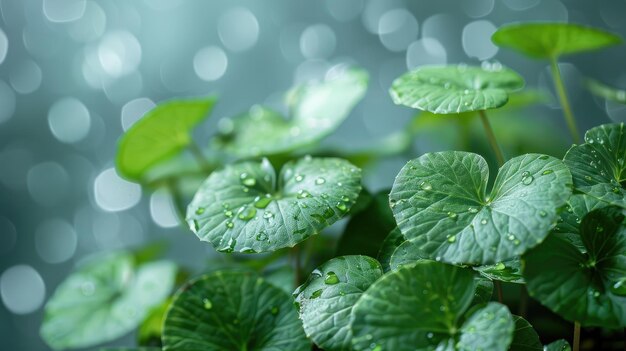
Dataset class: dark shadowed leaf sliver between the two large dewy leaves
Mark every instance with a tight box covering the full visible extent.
[336,191,396,256]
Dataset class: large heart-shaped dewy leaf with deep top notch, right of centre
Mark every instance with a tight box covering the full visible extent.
[390,151,572,265]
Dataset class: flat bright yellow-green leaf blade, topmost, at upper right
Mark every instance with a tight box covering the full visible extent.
[491,23,622,58]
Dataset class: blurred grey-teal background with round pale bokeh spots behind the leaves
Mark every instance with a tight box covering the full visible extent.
[0,0,626,351]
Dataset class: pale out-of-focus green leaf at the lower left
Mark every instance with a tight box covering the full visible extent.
[41,252,176,350]
